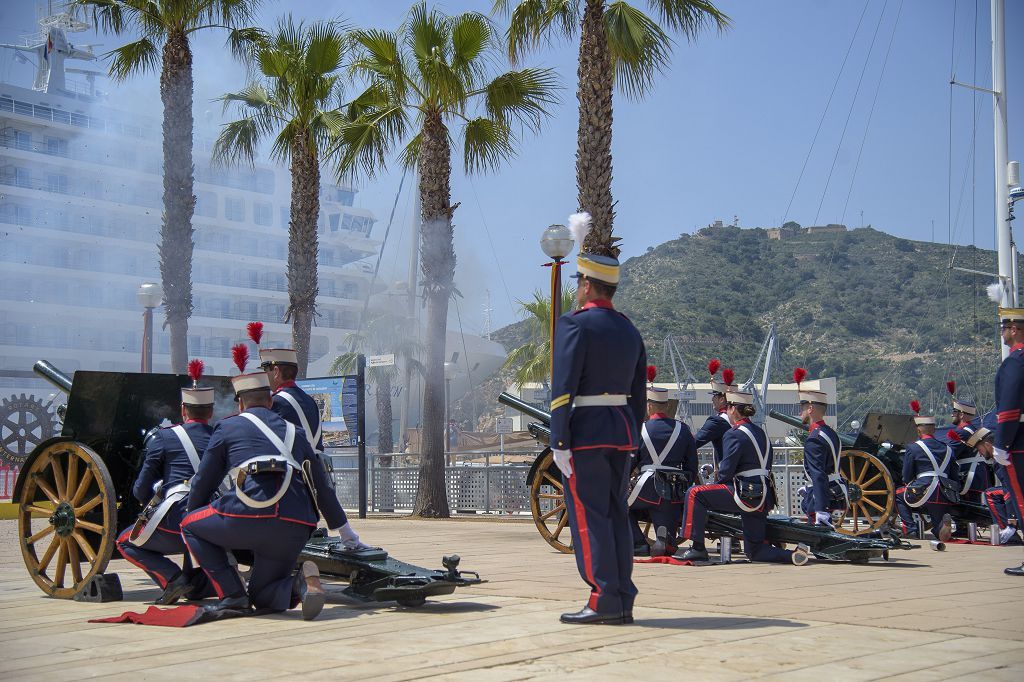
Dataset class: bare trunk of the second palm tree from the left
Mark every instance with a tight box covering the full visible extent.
[285,132,319,378]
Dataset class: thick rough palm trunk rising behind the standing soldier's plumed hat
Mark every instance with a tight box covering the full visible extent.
[577,0,618,258]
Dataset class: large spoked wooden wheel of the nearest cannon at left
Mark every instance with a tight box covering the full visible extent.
[17,440,117,599]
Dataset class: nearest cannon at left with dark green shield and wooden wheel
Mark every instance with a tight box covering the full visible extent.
[13,360,482,606]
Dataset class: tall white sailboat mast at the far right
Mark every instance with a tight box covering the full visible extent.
[992,0,1018,357]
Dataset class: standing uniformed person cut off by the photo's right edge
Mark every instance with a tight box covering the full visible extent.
[993,308,1024,576]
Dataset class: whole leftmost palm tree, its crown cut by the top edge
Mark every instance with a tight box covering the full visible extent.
[76,0,259,374]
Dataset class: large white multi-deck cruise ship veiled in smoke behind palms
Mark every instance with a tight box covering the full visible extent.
[0,5,381,464]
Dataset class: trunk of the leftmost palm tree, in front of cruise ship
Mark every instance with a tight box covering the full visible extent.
[160,32,196,374]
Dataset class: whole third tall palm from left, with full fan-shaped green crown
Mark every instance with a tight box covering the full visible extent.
[337,2,557,516]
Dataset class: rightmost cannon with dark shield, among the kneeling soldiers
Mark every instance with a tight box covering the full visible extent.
[768,410,991,536]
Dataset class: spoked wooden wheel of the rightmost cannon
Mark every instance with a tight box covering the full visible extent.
[836,450,896,536]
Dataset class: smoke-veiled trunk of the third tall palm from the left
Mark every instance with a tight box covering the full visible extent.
[413,112,458,517]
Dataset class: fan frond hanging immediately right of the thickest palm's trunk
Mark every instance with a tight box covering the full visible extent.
[604,0,672,99]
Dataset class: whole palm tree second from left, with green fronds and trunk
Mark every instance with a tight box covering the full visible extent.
[213,15,348,377]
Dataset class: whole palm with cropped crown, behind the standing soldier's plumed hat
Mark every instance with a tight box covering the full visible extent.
[495,0,729,257]
